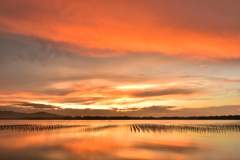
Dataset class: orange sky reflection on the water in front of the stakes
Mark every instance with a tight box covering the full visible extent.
[0,121,240,159]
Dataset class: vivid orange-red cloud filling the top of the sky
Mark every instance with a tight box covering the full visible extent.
[0,0,240,59]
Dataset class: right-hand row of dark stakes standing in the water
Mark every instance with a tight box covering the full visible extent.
[130,124,240,133]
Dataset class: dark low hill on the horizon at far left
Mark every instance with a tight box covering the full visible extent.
[0,111,63,119]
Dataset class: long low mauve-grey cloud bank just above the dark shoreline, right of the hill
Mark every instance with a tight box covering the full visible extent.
[47,105,240,117]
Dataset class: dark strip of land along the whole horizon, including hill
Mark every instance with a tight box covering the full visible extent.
[0,111,240,120]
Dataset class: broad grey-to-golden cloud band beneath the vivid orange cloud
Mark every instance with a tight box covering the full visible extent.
[0,28,240,108]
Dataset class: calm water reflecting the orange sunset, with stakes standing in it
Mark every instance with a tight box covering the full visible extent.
[0,120,240,160]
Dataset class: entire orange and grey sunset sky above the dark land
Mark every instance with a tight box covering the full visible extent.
[0,0,240,116]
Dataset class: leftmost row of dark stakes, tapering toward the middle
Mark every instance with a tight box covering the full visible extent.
[0,124,88,132]
